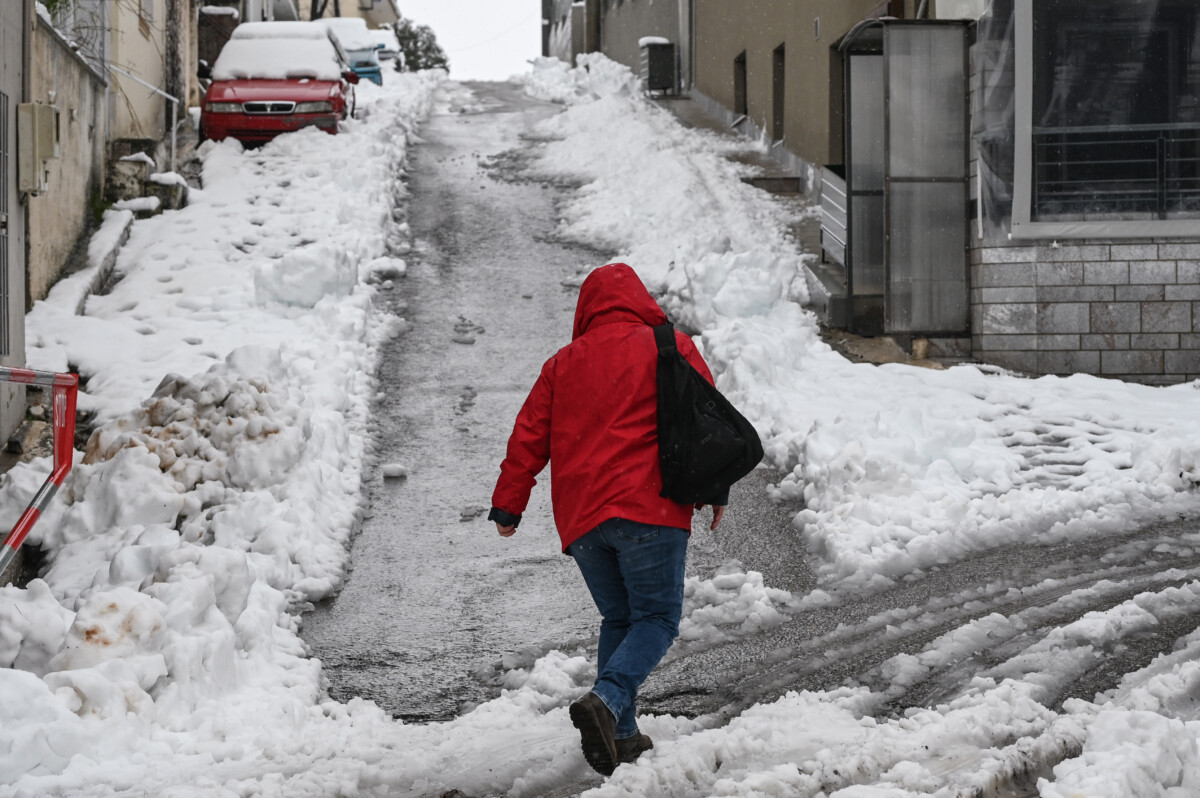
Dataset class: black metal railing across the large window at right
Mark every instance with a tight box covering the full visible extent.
[1033,124,1200,218]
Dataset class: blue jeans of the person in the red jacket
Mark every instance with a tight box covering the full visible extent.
[566,518,688,739]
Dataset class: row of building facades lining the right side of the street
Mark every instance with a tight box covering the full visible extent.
[544,0,1200,384]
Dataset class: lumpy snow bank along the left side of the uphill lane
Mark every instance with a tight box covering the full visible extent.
[0,74,442,796]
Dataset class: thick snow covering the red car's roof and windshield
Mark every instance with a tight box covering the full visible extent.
[212,38,342,80]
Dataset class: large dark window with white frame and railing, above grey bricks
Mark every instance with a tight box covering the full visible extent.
[1014,0,1200,235]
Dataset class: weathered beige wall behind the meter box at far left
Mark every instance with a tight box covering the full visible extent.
[28,12,108,302]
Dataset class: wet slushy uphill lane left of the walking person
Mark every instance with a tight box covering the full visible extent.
[305,84,604,720]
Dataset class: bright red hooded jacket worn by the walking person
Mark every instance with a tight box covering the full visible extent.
[492,263,713,551]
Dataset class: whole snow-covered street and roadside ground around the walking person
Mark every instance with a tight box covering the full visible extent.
[0,55,1200,798]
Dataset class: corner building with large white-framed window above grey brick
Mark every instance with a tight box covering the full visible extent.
[971,0,1200,384]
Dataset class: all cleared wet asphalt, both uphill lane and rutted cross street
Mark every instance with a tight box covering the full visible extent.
[304,84,1200,796]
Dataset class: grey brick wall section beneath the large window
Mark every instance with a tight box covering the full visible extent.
[971,240,1200,385]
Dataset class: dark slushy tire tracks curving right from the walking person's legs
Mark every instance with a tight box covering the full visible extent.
[642,522,1200,724]
